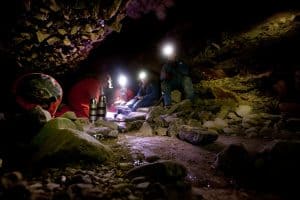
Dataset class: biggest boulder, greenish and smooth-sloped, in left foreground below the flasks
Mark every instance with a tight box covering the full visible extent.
[32,117,111,165]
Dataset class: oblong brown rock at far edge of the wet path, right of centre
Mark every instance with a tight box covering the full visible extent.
[178,125,218,145]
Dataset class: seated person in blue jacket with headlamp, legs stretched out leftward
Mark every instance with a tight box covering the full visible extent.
[122,72,160,111]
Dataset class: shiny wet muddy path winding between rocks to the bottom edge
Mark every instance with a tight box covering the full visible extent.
[118,133,283,200]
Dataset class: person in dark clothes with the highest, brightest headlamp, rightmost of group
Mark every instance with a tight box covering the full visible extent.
[160,44,194,107]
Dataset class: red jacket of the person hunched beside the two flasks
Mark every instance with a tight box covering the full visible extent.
[68,78,101,117]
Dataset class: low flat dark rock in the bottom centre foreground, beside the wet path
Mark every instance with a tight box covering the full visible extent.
[127,160,187,182]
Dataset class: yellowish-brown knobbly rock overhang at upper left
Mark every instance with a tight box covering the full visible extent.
[11,0,173,75]
